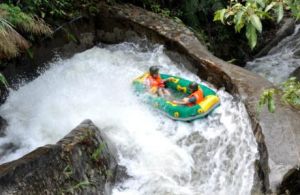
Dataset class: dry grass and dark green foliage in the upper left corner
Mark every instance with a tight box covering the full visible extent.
[0,0,98,58]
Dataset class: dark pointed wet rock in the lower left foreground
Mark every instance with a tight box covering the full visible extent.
[0,120,118,195]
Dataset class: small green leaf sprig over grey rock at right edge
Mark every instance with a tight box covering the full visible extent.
[259,77,300,113]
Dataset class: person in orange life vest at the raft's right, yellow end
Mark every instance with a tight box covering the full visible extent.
[173,82,204,106]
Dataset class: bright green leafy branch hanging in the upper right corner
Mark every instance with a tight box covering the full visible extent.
[214,0,300,49]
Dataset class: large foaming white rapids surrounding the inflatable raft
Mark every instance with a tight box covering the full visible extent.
[0,43,257,195]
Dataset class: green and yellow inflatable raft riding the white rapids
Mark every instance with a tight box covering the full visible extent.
[133,73,220,121]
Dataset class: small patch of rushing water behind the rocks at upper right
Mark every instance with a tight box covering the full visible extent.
[246,25,300,83]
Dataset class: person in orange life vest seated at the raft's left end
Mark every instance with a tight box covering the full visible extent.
[145,66,171,97]
